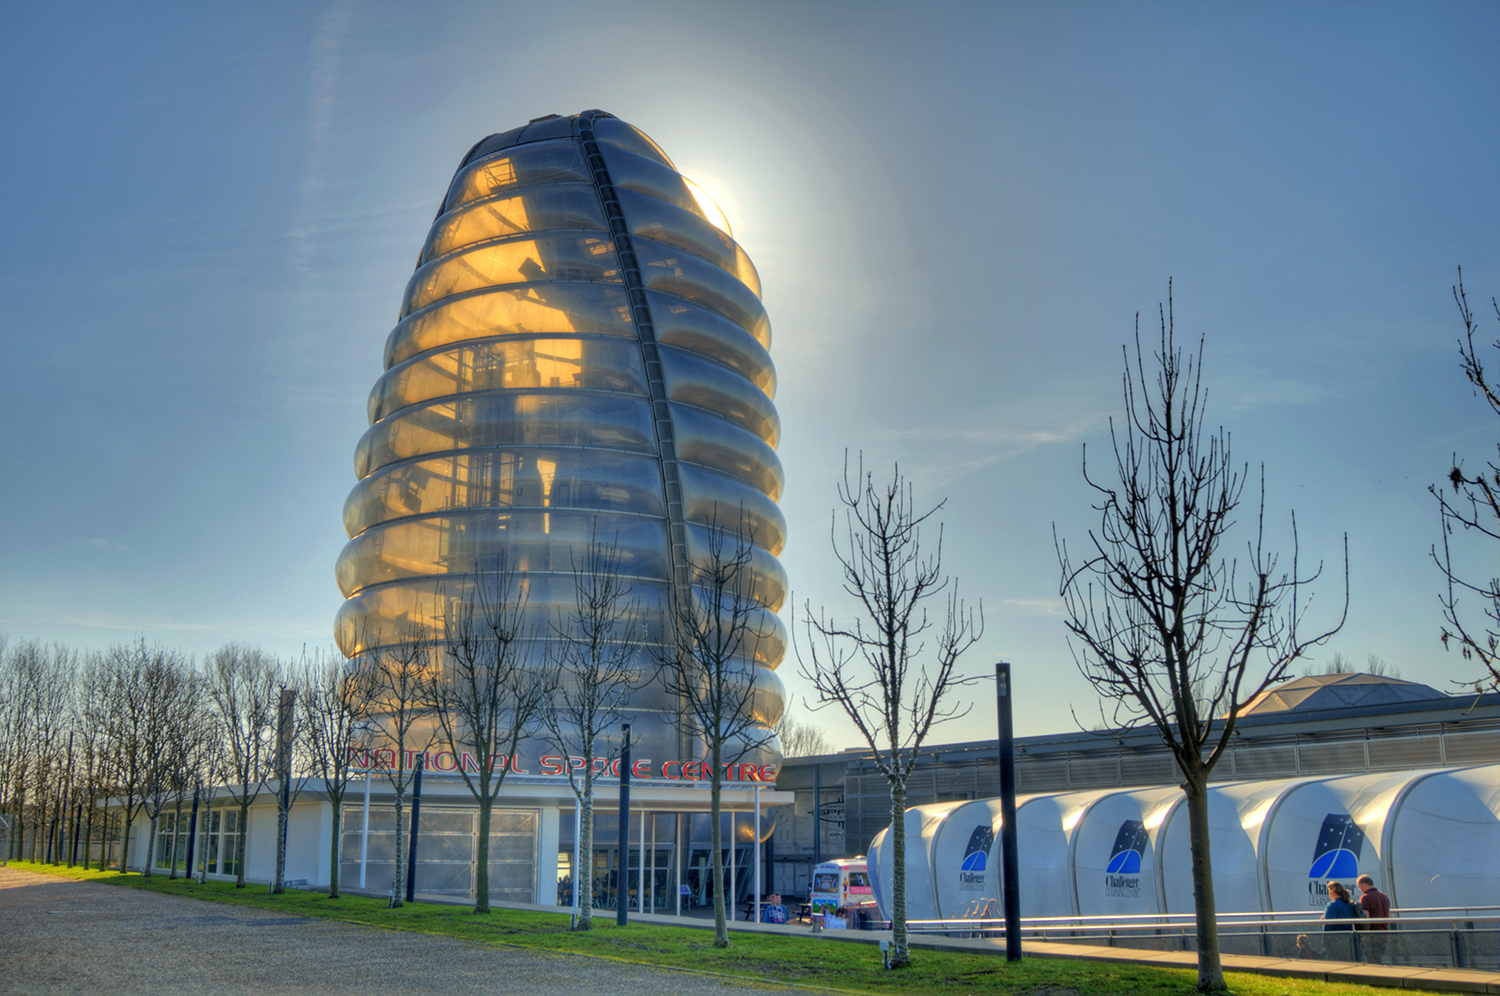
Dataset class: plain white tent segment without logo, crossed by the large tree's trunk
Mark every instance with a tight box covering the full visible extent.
[1157,782,1272,914]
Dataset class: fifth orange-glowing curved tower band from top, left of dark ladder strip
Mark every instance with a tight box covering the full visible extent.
[368,338,647,422]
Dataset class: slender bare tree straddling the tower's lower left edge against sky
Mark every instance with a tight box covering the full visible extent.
[299,653,374,899]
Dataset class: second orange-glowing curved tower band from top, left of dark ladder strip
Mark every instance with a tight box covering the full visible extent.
[419,183,609,266]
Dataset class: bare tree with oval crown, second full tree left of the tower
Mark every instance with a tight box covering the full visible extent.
[207,644,276,888]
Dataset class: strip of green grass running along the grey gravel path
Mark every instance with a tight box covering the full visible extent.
[9,861,1440,996]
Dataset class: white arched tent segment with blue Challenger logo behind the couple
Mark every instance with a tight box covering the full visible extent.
[1262,771,1428,914]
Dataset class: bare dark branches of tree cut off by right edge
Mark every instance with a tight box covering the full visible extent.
[1428,270,1500,689]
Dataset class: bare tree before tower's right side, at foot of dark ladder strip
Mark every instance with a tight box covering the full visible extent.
[669,512,773,948]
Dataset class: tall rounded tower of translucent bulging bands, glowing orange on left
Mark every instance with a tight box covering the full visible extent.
[336,111,788,762]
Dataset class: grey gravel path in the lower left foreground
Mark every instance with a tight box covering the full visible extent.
[0,867,828,996]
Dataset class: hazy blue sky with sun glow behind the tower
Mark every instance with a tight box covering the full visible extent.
[0,0,1500,746]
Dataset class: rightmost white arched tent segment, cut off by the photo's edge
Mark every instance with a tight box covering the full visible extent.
[1376,765,1500,908]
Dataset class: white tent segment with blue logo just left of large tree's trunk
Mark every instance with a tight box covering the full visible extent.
[1071,788,1182,917]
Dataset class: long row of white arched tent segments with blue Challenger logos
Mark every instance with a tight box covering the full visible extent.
[870,765,1500,920]
